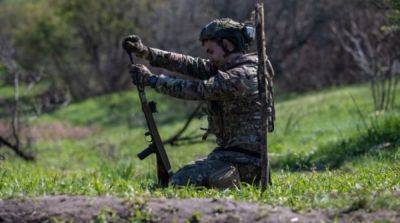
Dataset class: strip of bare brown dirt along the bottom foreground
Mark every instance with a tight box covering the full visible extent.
[0,196,400,222]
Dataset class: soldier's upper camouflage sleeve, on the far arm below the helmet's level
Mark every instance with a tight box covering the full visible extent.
[148,48,213,80]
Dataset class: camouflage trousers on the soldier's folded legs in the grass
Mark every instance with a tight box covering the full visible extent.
[171,148,261,189]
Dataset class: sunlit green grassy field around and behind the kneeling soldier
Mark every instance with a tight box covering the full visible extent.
[0,83,400,211]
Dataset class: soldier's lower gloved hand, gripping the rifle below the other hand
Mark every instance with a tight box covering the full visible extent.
[129,64,158,87]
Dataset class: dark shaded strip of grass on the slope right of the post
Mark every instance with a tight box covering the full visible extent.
[271,116,400,171]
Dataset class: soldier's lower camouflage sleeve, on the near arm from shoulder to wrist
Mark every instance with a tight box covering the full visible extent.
[155,65,257,101]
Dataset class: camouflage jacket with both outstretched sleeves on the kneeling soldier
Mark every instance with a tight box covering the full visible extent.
[149,48,261,157]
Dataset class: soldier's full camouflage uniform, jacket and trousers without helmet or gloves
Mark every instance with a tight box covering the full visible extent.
[148,48,261,188]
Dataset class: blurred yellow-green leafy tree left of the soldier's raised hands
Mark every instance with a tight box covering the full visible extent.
[11,0,152,99]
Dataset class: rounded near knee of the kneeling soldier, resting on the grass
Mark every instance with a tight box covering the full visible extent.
[208,165,240,189]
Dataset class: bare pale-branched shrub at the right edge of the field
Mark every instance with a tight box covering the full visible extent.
[330,9,399,110]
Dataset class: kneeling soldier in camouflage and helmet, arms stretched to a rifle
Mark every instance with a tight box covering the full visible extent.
[123,19,262,189]
